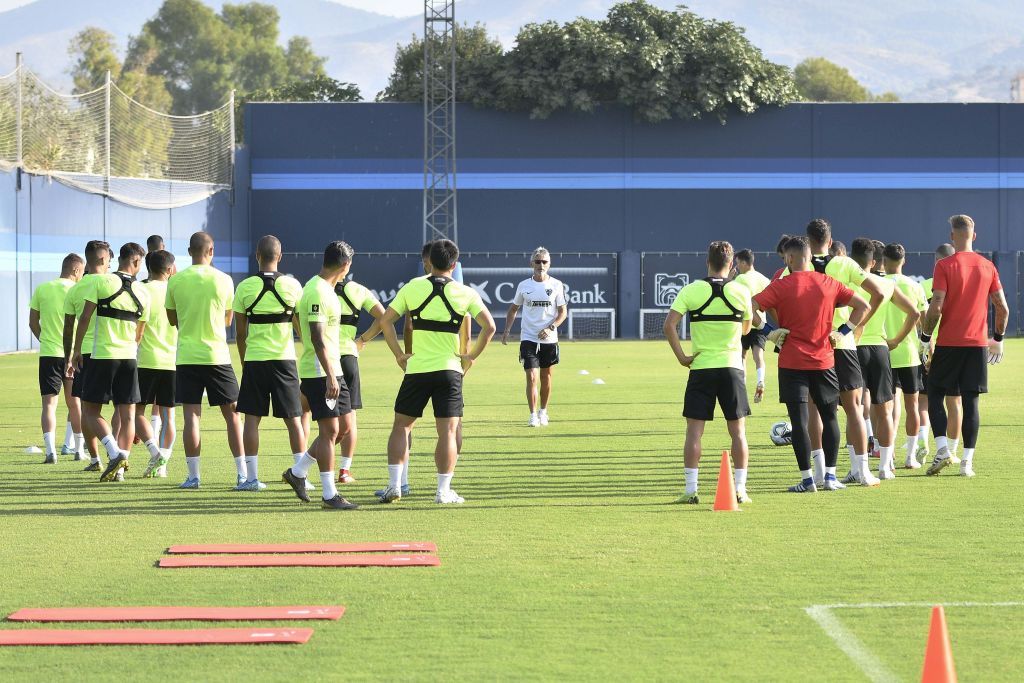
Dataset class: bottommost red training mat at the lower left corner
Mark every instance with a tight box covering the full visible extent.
[0,629,313,645]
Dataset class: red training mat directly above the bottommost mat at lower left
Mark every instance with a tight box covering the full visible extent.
[7,605,345,622]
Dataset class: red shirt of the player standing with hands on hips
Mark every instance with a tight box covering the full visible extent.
[754,270,856,370]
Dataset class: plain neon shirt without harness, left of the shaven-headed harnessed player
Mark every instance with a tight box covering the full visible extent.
[166,265,234,366]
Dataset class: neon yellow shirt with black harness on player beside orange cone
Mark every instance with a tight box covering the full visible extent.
[671,280,753,370]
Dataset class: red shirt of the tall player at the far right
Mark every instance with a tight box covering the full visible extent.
[937,252,1002,348]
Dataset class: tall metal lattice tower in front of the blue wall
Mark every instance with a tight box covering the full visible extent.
[423,0,459,243]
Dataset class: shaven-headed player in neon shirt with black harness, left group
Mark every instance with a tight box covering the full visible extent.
[234,234,306,492]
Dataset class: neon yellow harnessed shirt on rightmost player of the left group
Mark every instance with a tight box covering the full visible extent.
[388,278,484,375]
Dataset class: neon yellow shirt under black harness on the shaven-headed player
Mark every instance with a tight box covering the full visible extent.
[234,275,302,360]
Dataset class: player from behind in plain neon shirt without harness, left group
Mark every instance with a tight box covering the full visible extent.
[165,231,249,488]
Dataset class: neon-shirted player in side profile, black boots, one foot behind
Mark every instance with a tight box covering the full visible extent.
[282,242,359,510]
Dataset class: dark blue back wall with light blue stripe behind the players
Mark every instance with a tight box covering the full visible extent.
[246,103,1024,336]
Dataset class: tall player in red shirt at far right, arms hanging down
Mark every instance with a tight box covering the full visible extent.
[921,215,1010,477]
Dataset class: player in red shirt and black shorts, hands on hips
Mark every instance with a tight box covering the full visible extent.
[754,238,870,494]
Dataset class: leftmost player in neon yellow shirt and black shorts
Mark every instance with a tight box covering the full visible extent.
[29,254,85,465]
